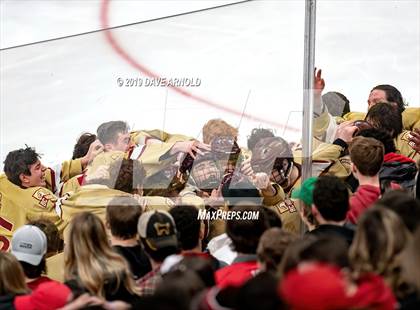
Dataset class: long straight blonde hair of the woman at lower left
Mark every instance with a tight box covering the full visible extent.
[64,212,138,297]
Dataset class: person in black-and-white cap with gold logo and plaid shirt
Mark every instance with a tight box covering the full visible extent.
[137,211,178,296]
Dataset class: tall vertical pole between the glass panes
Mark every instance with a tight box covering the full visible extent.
[302,0,316,182]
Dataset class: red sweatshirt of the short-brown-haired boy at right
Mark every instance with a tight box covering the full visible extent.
[347,183,401,224]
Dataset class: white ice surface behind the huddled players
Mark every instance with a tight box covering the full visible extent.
[0,0,420,168]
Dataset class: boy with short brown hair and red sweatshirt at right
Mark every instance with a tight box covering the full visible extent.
[347,137,399,224]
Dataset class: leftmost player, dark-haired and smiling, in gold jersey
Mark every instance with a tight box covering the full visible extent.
[0,147,82,250]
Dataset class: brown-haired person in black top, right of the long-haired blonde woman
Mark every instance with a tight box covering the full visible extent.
[106,196,152,280]
